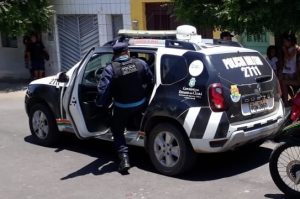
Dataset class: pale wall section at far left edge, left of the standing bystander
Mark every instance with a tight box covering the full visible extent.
[0,35,30,81]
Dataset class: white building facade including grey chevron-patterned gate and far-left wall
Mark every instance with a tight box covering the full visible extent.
[0,0,131,80]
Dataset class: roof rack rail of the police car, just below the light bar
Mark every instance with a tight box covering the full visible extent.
[128,39,201,51]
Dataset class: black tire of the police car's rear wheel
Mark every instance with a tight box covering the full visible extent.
[147,123,196,176]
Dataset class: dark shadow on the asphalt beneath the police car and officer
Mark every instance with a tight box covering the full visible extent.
[25,134,277,181]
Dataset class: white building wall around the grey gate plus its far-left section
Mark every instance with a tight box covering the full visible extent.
[0,0,131,80]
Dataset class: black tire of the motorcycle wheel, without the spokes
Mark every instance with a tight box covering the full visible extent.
[269,142,300,198]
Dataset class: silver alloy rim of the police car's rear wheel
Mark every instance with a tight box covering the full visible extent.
[154,131,180,168]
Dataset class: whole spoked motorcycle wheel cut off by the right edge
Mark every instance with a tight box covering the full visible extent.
[269,142,300,198]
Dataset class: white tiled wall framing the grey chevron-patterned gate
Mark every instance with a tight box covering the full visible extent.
[46,0,131,73]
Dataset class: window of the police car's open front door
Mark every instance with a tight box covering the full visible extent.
[82,53,113,86]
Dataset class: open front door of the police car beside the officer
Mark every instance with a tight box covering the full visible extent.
[63,47,113,139]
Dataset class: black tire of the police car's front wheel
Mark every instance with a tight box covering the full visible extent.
[29,104,59,146]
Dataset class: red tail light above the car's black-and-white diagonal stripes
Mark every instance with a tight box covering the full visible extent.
[209,83,227,112]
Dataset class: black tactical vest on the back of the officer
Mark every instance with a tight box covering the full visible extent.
[112,59,146,104]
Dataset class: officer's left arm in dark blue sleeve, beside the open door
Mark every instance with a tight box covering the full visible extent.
[96,64,113,107]
